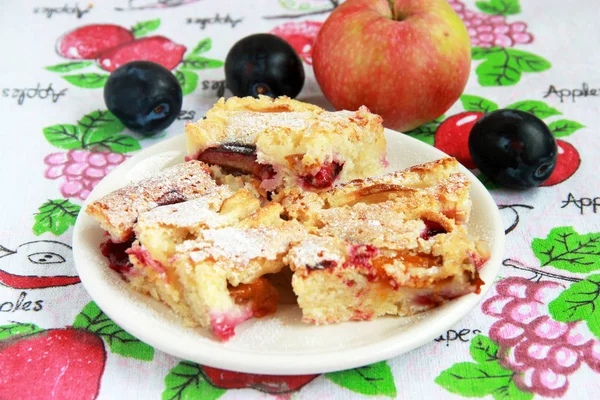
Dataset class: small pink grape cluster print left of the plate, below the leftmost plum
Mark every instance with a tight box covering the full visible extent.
[44,150,126,200]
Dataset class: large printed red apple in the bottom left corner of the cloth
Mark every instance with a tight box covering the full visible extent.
[0,328,106,400]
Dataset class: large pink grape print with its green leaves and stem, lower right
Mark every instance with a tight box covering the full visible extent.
[435,226,600,399]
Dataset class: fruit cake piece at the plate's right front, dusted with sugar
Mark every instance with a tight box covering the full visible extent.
[277,159,489,324]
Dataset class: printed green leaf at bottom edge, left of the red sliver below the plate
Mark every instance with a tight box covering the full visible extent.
[162,361,226,400]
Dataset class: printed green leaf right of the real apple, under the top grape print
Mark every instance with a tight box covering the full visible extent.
[472,47,552,86]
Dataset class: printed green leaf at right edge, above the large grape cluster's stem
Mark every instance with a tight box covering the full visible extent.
[531,226,600,273]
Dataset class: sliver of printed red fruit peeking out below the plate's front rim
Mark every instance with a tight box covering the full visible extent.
[202,366,318,394]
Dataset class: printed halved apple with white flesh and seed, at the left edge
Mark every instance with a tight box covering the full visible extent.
[0,240,80,289]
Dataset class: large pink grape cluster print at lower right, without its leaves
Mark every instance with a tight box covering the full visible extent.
[482,277,600,397]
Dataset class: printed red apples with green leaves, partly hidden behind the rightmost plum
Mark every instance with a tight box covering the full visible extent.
[407,94,585,189]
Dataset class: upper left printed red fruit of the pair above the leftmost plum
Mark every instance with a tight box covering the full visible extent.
[56,24,133,60]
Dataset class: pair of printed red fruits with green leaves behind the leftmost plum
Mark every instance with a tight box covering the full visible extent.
[46,19,224,96]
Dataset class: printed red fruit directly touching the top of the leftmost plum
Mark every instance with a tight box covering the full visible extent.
[98,36,186,72]
